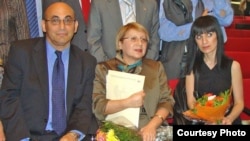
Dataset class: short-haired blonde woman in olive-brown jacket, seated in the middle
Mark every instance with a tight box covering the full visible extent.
[93,22,174,141]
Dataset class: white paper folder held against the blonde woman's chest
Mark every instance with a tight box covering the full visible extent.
[106,70,145,127]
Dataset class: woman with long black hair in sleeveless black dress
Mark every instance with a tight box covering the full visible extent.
[186,16,244,125]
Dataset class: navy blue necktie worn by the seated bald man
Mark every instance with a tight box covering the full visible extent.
[52,51,66,135]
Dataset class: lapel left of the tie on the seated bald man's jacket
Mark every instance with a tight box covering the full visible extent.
[32,38,49,109]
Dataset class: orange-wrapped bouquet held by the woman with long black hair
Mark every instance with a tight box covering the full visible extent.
[183,90,231,123]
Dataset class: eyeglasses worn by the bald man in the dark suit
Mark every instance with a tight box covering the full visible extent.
[43,16,76,25]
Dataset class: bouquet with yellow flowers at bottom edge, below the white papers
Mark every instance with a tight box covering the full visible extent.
[96,121,142,141]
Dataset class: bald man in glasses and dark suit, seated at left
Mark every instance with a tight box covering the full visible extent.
[0,2,96,141]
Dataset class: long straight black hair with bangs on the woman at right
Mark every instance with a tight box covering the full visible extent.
[186,15,228,74]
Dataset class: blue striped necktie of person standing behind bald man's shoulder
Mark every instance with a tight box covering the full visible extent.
[25,0,39,38]
